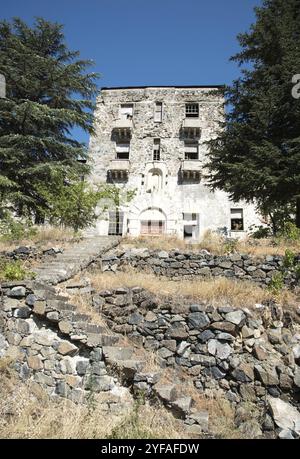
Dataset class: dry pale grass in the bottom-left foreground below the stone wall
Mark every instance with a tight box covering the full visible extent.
[0,361,183,439]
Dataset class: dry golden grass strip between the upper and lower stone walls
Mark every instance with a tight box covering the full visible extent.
[90,268,298,307]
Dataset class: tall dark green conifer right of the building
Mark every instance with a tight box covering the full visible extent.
[207,0,300,227]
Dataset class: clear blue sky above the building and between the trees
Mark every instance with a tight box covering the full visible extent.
[0,0,261,141]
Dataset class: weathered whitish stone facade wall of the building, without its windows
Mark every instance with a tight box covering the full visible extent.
[88,87,262,239]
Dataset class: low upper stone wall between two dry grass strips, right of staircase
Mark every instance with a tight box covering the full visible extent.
[101,248,298,285]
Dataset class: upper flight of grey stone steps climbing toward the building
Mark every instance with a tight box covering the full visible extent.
[33,236,120,285]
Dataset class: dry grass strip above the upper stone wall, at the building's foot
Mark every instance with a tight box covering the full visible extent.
[121,231,300,257]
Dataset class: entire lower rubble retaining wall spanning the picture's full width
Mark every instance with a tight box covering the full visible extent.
[0,274,300,438]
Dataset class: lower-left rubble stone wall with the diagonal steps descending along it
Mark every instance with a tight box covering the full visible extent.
[0,282,213,435]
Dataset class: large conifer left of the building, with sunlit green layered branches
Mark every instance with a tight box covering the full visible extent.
[0,18,98,218]
